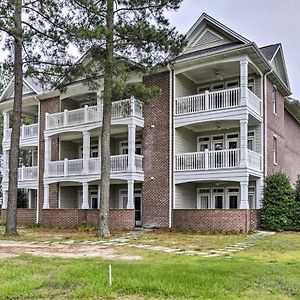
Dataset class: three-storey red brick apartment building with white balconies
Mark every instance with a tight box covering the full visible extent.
[0,14,300,231]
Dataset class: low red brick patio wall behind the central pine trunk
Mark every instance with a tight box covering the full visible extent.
[41,209,135,230]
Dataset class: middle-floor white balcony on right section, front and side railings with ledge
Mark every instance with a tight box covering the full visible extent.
[175,149,262,183]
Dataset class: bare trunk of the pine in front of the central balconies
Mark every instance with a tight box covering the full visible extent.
[97,0,114,237]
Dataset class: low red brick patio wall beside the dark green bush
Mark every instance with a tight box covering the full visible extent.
[173,209,259,232]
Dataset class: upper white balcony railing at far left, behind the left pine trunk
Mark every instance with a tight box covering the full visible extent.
[3,124,39,147]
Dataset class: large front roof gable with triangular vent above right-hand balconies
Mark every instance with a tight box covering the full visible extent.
[183,13,250,53]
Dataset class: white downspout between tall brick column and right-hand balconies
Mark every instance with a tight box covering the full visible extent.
[167,64,174,228]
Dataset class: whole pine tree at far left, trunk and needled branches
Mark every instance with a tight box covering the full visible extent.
[0,0,72,235]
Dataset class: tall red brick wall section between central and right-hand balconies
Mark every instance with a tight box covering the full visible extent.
[142,72,170,227]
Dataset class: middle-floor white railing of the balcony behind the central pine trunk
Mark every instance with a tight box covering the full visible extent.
[48,155,142,177]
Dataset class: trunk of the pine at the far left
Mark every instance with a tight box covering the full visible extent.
[5,0,23,235]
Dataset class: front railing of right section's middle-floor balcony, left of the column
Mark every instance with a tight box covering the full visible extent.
[175,149,240,171]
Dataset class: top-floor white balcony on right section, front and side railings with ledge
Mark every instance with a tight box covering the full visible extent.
[175,88,261,126]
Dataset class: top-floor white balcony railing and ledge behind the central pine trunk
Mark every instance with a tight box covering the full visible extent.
[46,98,144,133]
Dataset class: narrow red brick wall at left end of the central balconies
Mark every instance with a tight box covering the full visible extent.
[38,97,60,217]
